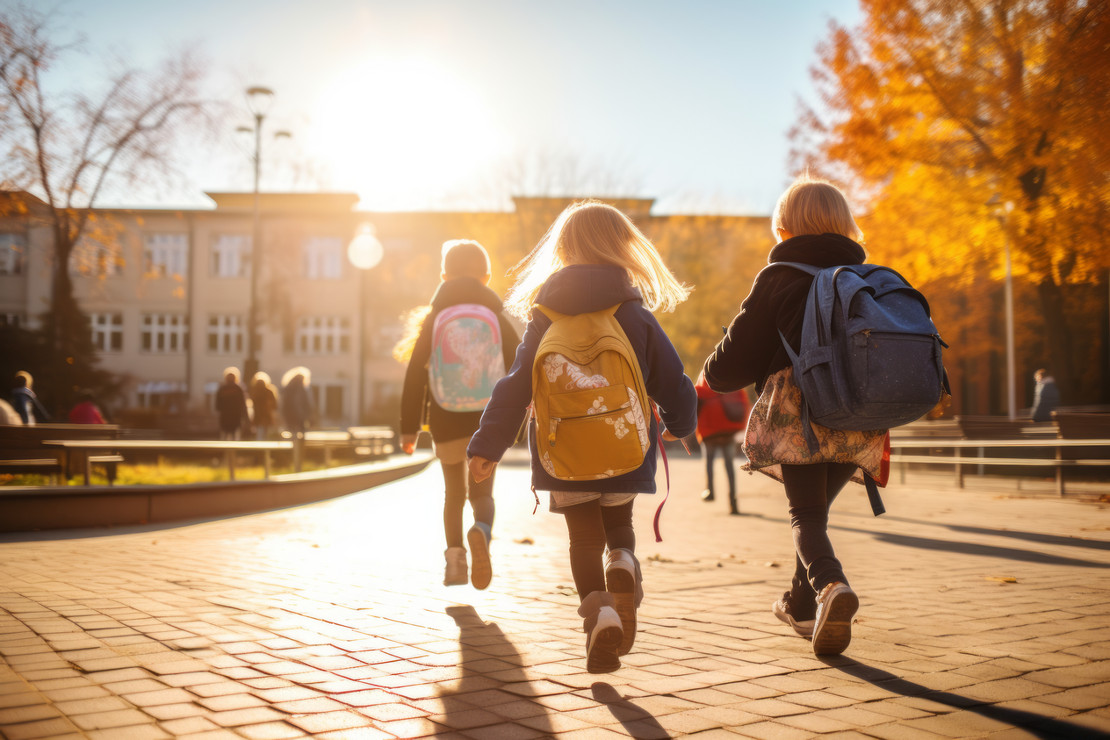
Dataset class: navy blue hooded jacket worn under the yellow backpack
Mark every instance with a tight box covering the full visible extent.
[466,265,697,494]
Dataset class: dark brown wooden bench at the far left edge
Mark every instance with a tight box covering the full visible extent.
[0,424,123,485]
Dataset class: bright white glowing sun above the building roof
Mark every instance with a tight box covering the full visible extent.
[309,59,505,210]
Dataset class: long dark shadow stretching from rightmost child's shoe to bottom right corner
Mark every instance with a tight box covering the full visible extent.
[821,656,1107,740]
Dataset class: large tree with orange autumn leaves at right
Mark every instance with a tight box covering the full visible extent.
[793,0,1110,406]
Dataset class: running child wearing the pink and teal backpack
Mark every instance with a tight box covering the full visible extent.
[394,240,518,589]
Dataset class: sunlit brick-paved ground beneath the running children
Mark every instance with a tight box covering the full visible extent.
[0,460,1110,740]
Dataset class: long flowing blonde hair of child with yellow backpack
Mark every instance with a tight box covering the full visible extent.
[505,200,690,321]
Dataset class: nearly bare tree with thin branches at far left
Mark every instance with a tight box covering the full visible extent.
[0,6,202,410]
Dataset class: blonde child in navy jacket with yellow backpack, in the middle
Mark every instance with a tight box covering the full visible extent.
[466,201,697,673]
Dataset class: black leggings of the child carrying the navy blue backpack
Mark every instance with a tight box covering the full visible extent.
[783,463,857,619]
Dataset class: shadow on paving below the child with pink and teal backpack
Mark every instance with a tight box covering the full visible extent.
[440,605,555,737]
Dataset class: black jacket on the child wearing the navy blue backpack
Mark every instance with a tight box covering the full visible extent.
[704,234,867,393]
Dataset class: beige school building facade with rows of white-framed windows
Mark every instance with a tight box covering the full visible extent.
[0,193,768,426]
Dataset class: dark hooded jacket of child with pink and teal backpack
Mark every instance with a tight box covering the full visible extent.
[401,277,519,444]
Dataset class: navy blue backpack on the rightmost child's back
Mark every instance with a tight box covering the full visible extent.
[770,262,949,514]
